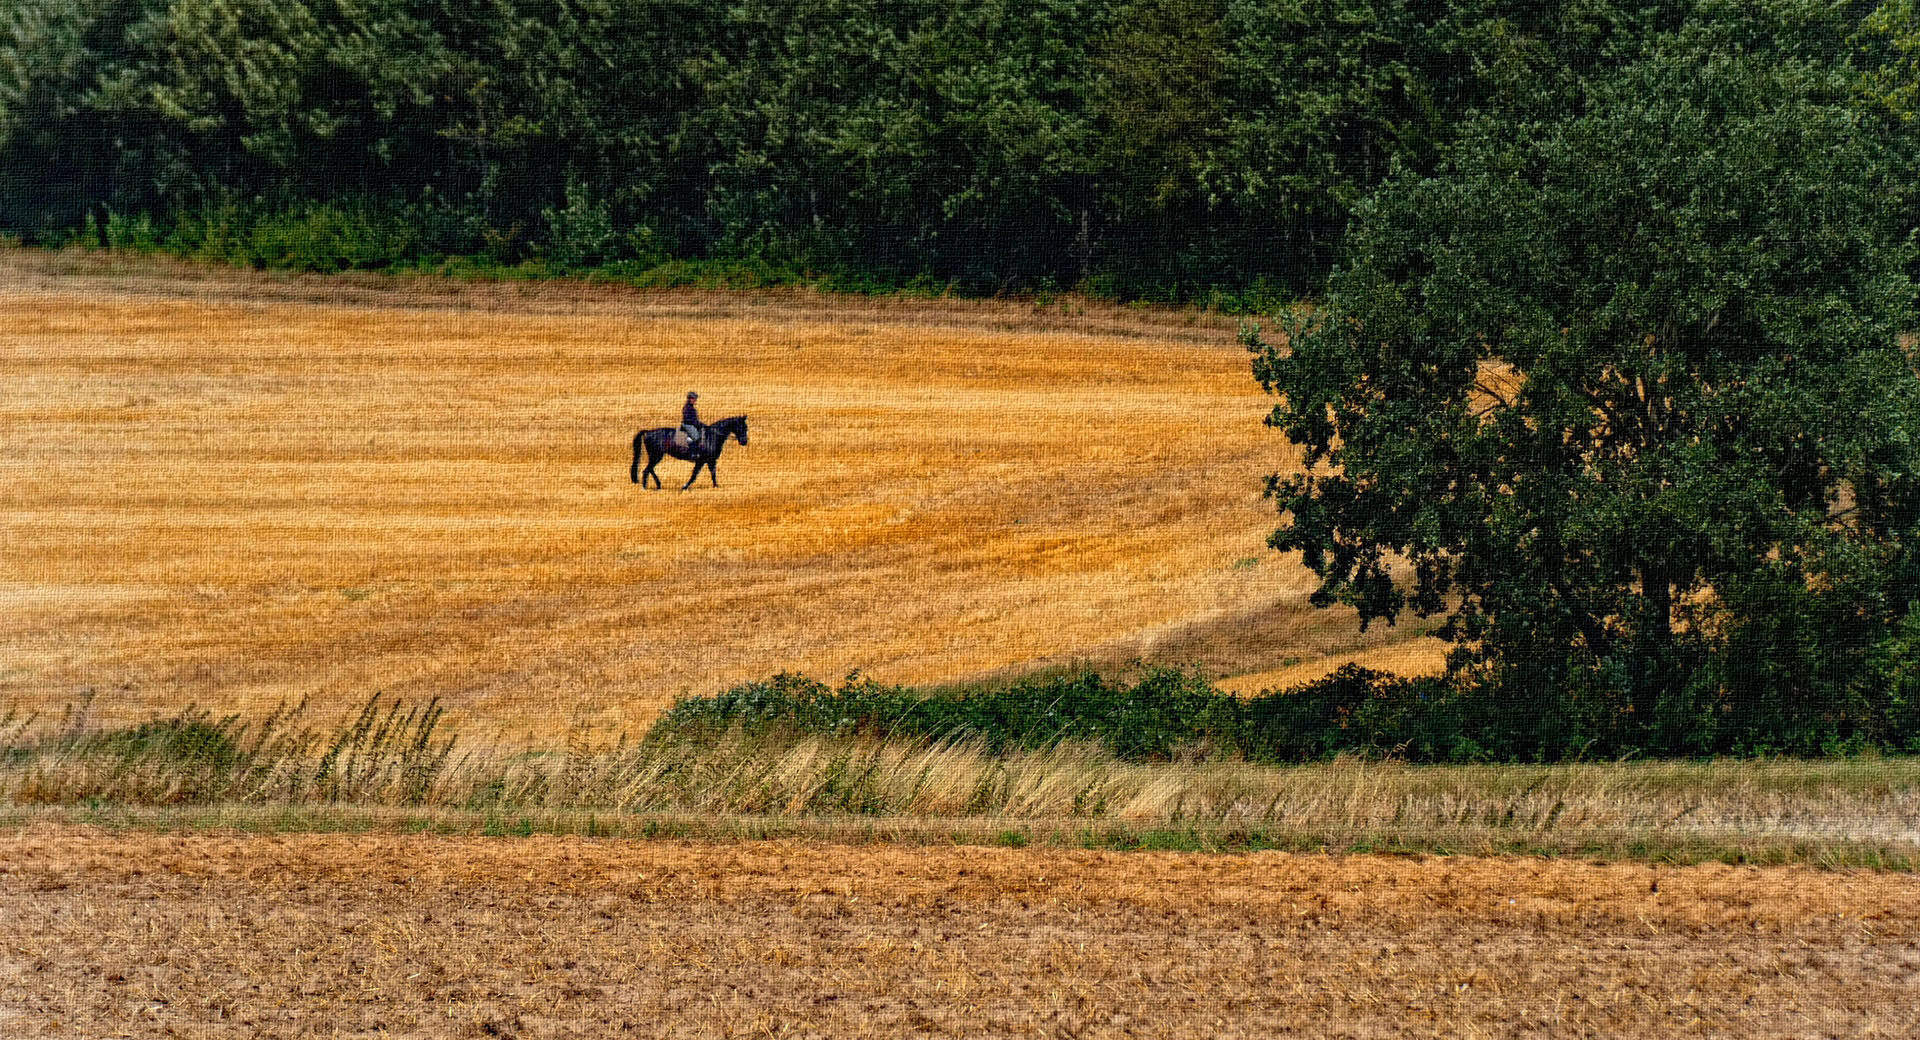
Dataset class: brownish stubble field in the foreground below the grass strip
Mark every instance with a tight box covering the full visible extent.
[0,827,1920,1038]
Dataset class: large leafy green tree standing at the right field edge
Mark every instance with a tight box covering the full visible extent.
[1252,4,1920,750]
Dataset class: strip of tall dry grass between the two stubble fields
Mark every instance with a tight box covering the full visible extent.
[0,698,1920,858]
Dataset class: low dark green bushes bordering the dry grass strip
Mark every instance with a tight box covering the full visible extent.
[647,660,1920,767]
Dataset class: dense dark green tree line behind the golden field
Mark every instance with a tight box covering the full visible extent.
[11,0,1912,295]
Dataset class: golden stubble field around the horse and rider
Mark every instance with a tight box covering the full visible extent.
[0,253,1436,743]
